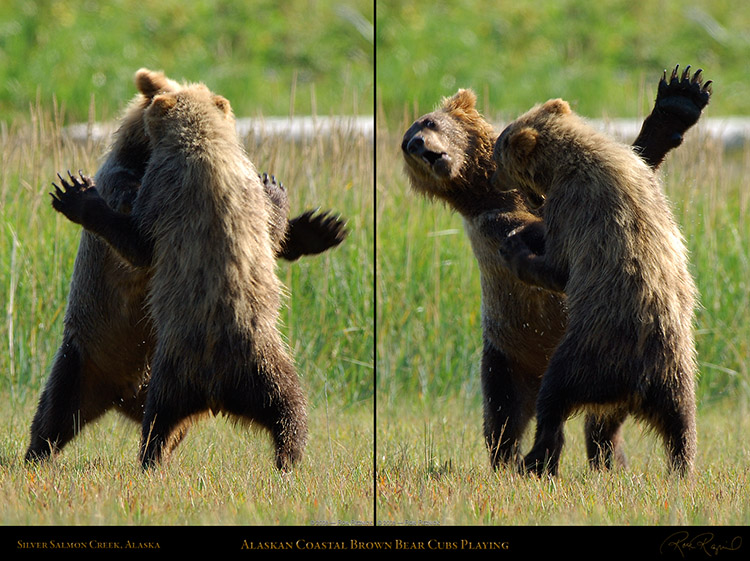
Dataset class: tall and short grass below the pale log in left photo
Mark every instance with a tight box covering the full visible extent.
[0,98,374,525]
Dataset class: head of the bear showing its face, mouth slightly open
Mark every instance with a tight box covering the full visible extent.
[401,89,493,197]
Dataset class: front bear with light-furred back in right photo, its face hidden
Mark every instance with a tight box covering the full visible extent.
[494,99,696,475]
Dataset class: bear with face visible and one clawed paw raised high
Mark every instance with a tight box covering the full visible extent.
[401,67,711,467]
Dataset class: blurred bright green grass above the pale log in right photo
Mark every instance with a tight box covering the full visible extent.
[376,0,750,118]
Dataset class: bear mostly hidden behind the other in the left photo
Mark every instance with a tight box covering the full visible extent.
[26,69,346,460]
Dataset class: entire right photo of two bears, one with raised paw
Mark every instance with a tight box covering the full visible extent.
[375,0,750,540]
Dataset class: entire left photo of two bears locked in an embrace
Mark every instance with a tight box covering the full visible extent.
[0,0,376,532]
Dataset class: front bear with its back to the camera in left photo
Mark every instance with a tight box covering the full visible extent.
[50,84,307,469]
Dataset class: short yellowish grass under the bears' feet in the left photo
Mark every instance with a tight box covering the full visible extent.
[0,396,373,526]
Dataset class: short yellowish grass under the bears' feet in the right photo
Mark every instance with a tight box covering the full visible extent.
[377,396,750,524]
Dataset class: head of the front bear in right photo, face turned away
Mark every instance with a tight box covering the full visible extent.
[492,99,573,203]
